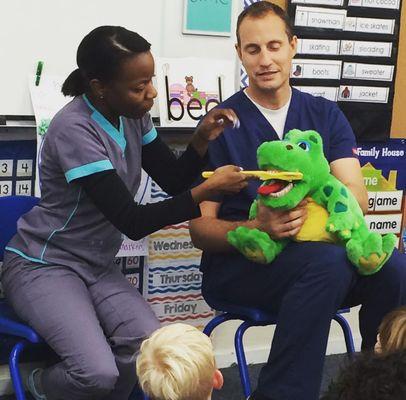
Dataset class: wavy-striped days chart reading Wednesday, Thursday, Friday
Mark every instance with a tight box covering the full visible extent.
[143,155,214,327]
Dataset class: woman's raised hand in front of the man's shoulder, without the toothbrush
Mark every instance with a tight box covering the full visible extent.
[191,108,240,157]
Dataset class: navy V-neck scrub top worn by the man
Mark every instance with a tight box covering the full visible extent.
[209,88,356,220]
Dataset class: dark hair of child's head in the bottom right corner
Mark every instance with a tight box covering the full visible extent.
[321,351,406,400]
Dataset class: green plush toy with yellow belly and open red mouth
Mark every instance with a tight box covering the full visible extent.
[227,129,396,275]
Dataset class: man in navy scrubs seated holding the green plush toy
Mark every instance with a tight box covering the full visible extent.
[191,1,406,400]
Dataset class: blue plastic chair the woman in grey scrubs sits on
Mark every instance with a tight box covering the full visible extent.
[0,196,44,400]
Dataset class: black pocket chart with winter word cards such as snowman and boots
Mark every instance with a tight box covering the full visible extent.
[288,0,402,141]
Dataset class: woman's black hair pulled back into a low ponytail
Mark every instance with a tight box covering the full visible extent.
[62,26,151,96]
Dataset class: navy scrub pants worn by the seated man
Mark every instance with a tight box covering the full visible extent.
[202,242,406,400]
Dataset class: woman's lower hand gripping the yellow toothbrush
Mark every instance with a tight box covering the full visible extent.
[192,165,250,203]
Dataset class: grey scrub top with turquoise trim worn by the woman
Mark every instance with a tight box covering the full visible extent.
[6,95,157,269]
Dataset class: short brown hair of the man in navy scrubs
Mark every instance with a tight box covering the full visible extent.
[236,1,293,45]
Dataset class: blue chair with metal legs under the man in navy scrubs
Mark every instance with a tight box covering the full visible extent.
[203,298,355,398]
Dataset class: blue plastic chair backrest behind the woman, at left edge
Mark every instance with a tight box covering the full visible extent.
[0,196,39,261]
